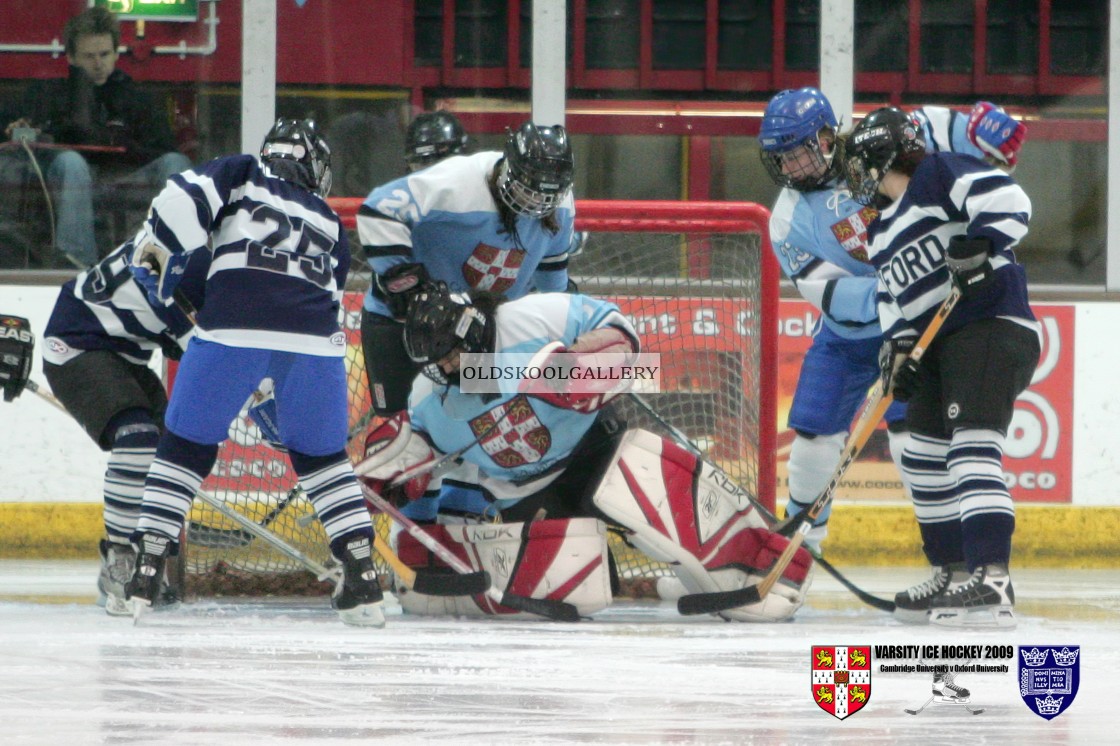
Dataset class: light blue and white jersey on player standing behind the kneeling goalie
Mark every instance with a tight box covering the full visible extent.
[357,151,576,316]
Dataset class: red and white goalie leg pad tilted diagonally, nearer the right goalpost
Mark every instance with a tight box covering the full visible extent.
[592,430,812,622]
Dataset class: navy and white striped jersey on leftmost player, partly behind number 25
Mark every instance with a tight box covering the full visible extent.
[43,241,209,365]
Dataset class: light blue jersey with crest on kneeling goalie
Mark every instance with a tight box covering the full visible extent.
[410,292,637,483]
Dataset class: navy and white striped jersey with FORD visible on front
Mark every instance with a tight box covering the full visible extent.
[868,153,1039,338]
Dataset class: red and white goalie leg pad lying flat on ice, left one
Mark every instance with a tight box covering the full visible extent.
[394,517,610,618]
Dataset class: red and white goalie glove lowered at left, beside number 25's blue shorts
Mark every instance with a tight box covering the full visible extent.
[354,412,436,502]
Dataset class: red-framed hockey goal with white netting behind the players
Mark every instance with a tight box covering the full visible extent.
[181,199,778,596]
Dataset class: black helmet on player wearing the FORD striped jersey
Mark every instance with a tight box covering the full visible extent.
[844,106,925,205]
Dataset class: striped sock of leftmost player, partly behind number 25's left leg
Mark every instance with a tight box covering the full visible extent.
[103,408,159,543]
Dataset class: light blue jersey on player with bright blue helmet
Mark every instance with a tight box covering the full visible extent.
[769,106,983,339]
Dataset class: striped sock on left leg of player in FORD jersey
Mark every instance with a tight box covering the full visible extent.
[902,432,964,567]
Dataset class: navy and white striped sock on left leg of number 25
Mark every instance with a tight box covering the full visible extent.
[132,430,217,544]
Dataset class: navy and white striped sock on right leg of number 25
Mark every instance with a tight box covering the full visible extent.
[288,443,373,548]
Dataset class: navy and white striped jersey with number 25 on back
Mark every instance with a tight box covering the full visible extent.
[136,156,351,357]
